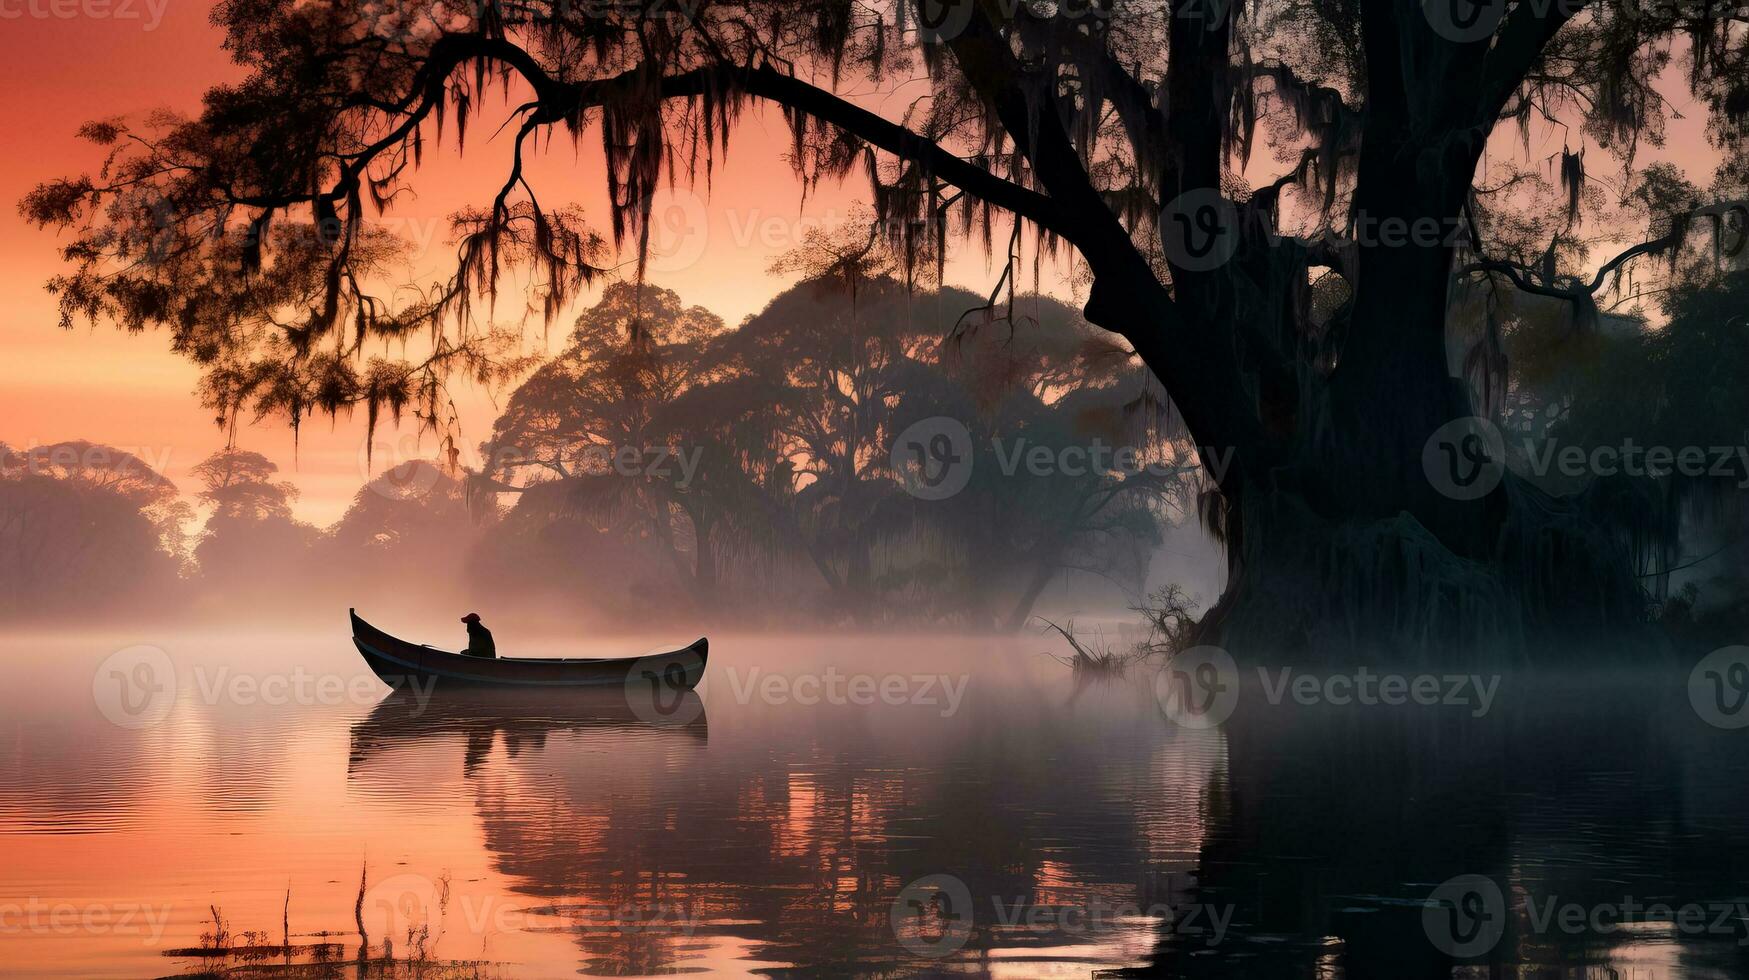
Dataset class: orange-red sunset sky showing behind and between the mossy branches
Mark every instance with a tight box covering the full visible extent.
[0,9,1711,523]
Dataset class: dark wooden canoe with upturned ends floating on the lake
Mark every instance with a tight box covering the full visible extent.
[348,609,710,695]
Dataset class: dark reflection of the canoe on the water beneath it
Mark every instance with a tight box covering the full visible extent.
[348,688,710,775]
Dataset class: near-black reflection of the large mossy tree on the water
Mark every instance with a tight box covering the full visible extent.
[1132,672,1749,978]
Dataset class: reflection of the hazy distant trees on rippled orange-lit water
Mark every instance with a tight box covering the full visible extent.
[348,668,1221,977]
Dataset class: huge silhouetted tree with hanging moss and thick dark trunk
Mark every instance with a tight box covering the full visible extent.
[23,0,1749,654]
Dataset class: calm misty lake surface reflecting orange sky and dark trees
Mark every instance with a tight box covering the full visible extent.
[0,621,1749,978]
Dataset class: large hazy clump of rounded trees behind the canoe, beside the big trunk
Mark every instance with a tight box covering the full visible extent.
[472,275,1196,628]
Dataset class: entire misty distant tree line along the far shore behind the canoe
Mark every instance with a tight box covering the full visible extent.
[0,276,1200,628]
